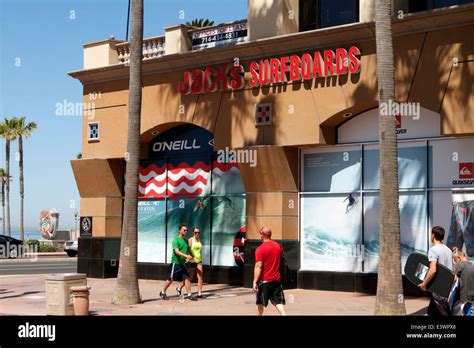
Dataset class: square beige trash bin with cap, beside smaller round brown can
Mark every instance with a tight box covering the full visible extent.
[46,273,87,315]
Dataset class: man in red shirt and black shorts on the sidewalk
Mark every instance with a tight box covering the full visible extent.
[253,227,286,315]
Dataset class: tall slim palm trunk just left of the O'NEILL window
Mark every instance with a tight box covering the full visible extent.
[112,0,143,304]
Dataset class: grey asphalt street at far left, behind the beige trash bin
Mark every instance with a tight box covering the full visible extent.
[0,256,77,275]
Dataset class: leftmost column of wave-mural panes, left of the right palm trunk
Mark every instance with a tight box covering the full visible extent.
[301,146,362,272]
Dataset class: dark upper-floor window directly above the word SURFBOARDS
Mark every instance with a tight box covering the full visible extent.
[299,0,359,31]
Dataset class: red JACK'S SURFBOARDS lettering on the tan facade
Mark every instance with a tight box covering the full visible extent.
[178,46,360,94]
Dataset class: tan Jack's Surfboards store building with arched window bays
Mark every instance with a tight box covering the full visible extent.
[69,0,474,292]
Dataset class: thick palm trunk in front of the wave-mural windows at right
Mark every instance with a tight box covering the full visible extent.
[375,0,406,315]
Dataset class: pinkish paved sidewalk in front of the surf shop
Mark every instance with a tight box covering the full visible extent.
[0,274,428,315]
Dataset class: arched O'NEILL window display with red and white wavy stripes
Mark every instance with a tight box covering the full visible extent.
[138,125,245,266]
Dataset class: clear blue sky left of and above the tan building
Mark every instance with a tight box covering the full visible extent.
[0,0,247,229]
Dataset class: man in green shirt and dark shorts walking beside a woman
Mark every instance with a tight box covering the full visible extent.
[160,224,197,301]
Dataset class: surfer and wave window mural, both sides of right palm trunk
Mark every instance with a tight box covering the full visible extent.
[301,144,428,273]
